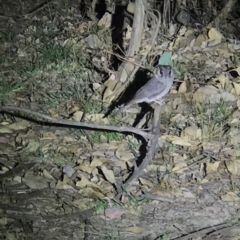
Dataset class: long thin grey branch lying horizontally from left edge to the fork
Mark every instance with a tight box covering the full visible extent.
[0,106,152,139]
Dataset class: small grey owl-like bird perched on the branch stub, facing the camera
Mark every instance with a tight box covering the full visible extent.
[113,65,174,116]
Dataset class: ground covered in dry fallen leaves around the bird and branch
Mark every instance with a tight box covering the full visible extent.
[0,1,240,239]
